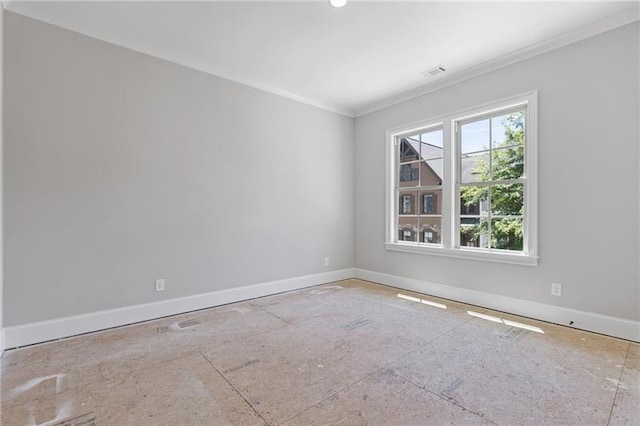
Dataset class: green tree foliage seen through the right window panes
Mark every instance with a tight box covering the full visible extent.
[460,112,525,250]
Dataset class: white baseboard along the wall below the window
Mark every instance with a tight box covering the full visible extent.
[355,268,640,342]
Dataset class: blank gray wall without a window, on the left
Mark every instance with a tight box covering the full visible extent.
[4,12,354,326]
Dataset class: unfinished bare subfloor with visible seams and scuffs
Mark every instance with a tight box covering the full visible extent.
[0,280,640,426]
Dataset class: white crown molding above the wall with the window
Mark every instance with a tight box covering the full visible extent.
[355,3,640,117]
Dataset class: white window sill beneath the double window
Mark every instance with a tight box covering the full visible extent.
[384,243,538,266]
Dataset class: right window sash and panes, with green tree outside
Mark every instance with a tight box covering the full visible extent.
[456,105,526,251]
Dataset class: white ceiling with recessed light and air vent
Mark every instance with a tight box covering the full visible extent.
[6,0,638,116]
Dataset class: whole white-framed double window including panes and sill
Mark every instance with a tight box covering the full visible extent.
[386,92,537,265]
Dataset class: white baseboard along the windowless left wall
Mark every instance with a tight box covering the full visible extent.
[2,268,354,349]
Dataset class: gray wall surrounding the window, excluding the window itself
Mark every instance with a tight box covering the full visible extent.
[355,23,640,320]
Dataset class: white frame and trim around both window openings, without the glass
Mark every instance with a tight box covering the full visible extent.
[385,90,538,266]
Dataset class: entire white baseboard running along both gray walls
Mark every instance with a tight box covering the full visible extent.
[0,268,640,355]
